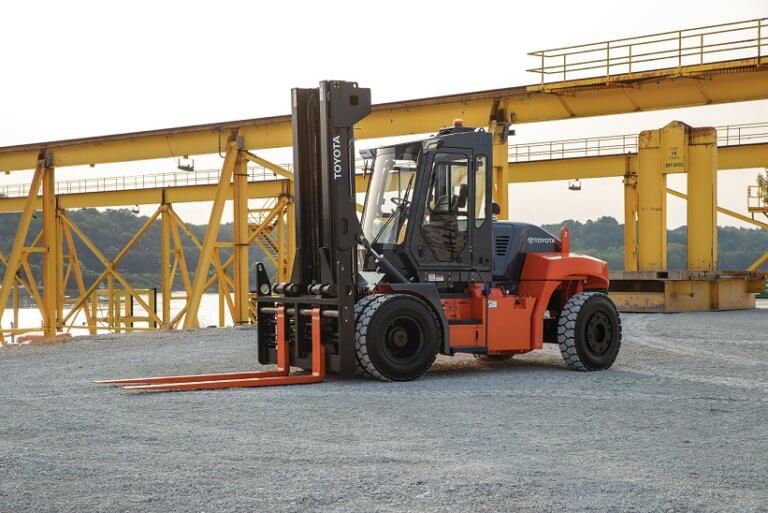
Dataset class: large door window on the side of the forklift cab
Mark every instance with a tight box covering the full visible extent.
[421,153,469,262]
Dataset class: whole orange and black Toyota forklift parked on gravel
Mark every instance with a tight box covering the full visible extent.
[100,81,622,391]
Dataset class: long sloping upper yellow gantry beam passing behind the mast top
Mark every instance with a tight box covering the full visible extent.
[0,58,768,171]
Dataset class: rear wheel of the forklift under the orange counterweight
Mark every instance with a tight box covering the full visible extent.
[557,292,621,371]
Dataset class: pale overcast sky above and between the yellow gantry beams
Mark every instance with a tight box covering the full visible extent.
[0,0,768,227]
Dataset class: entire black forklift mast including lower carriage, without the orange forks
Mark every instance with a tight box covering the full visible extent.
[258,81,371,375]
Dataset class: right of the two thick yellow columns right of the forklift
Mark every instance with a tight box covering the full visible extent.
[686,128,717,271]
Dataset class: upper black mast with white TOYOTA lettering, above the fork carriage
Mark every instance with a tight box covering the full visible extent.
[292,81,371,286]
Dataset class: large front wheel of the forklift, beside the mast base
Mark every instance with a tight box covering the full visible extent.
[355,294,442,381]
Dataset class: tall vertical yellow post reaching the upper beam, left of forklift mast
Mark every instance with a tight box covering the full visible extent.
[231,150,250,325]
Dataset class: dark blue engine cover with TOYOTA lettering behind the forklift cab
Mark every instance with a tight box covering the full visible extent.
[493,221,560,281]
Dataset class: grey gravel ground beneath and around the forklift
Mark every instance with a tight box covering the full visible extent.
[0,310,768,513]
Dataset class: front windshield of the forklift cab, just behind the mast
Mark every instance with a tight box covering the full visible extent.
[363,145,421,244]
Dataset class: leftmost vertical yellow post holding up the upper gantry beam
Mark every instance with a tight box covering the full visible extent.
[43,162,59,338]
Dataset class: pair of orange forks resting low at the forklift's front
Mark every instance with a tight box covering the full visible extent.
[96,306,325,392]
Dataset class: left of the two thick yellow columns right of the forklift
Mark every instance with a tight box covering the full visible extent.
[637,129,667,271]
